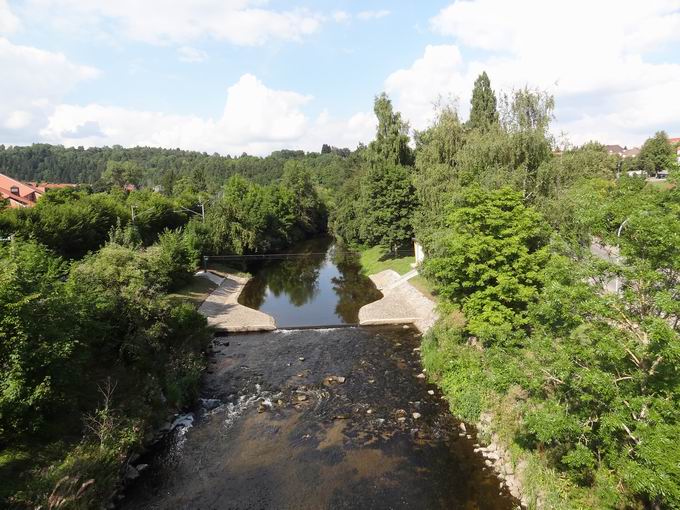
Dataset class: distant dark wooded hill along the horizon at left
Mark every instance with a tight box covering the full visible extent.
[0,144,356,192]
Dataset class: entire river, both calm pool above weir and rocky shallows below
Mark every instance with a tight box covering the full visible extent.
[123,240,516,509]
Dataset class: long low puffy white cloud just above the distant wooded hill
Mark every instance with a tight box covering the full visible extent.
[41,74,375,155]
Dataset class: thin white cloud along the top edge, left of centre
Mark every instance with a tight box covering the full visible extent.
[32,0,322,46]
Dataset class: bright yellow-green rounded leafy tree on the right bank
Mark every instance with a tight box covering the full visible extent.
[425,188,548,341]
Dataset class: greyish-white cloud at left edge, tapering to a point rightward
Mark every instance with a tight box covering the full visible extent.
[0,37,99,143]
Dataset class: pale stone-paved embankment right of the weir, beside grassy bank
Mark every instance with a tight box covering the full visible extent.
[359,269,437,333]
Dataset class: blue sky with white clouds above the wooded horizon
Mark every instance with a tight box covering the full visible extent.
[0,0,680,155]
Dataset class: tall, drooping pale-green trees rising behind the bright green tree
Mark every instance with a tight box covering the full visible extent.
[413,89,556,250]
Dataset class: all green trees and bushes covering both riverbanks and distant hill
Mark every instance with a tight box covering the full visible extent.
[0,73,680,508]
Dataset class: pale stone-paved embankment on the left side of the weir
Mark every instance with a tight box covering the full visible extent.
[198,273,276,333]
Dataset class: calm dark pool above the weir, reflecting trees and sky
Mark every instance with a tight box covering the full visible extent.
[239,238,381,327]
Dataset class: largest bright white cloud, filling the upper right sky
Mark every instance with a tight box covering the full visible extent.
[422,0,680,144]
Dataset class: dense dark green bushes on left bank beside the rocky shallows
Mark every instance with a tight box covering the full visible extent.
[0,238,209,508]
